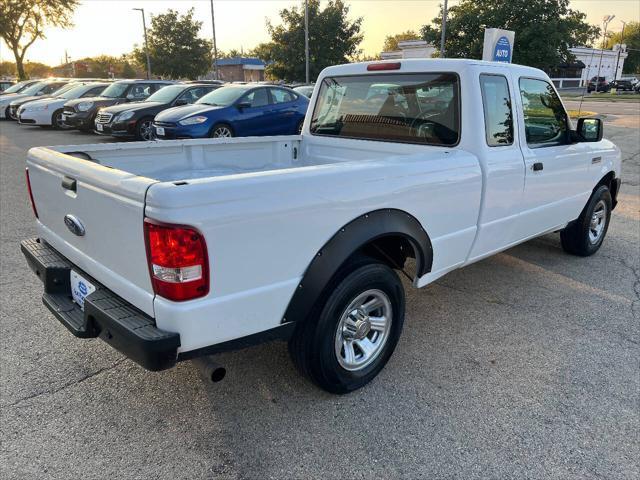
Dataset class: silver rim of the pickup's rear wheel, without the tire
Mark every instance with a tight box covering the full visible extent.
[335,289,393,372]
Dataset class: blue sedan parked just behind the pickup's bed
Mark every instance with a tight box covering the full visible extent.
[153,85,309,140]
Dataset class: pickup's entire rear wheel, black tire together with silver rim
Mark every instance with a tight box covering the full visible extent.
[289,257,404,394]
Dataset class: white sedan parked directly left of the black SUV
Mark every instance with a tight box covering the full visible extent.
[18,82,109,129]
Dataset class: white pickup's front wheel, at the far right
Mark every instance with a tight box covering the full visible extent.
[560,185,612,257]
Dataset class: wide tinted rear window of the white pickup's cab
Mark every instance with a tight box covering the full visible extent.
[311,73,460,145]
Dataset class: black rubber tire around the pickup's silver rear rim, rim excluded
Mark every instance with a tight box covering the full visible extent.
[289,256,405,394]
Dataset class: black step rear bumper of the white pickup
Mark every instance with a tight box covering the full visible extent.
[20,238,180,371]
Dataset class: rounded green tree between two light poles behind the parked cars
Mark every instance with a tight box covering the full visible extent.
[133,8,213,78]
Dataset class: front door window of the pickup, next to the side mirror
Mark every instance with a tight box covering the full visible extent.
[520,78,568,147]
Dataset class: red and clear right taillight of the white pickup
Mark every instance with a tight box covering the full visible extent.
[144,218,209,302]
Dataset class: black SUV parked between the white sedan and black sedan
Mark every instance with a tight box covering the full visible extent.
[62,80,174,131]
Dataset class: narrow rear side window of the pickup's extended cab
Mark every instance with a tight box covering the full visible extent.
[480,75,513,147]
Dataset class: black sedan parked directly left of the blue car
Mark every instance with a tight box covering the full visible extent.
[95,83,220,140]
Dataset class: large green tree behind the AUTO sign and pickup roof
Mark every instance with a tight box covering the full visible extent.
[421,0,599,69]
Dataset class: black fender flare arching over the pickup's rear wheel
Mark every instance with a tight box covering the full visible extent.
[282,209,433,323]
